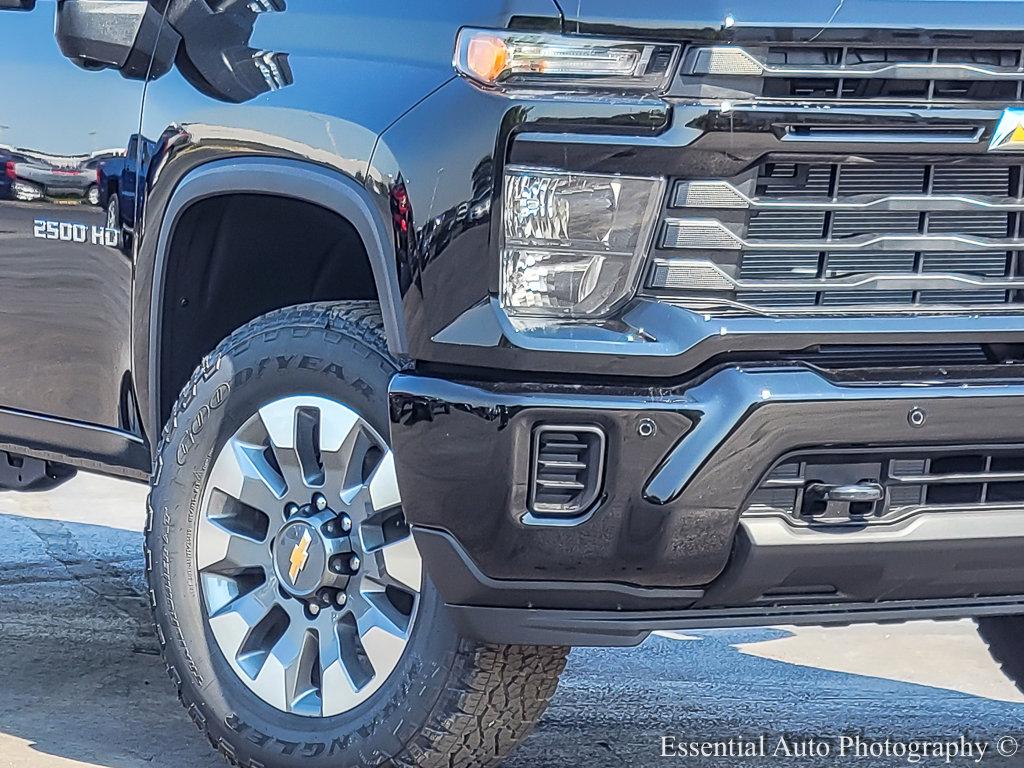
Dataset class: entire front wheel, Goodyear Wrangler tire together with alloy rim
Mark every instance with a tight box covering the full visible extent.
[146,302,567,768]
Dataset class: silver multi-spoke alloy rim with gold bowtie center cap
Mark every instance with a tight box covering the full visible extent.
[196,396,423,717]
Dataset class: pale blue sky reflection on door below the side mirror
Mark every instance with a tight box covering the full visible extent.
[0,0,142,155]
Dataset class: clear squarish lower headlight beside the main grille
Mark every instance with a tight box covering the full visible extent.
[501,168,665,317]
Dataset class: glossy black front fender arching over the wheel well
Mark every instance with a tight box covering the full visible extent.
[134,0,561,444]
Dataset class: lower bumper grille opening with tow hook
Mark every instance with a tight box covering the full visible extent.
[743,449,1024,525]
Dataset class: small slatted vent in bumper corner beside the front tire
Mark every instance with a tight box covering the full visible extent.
[529,424,604,517]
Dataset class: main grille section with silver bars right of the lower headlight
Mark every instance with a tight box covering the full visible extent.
[648,158,1024,312]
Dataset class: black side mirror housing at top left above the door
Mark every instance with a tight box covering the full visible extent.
[54,0,180,80]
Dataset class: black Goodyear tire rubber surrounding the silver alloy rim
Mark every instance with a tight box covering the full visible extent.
[145,302,568,768]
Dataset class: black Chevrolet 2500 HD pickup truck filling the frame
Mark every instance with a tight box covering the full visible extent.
[0,0,1024,768]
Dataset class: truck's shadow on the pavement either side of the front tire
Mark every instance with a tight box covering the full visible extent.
[0,515,1024,768]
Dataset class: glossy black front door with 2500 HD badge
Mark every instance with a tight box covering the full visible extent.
[0,0,148,428]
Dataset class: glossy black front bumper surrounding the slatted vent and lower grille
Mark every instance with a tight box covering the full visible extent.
[391,366,1024,609]
